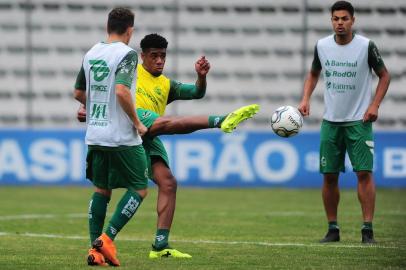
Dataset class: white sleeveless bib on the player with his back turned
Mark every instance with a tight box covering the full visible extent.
[83,42,142,147]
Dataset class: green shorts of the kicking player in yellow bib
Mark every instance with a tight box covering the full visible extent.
[137,108,169,179]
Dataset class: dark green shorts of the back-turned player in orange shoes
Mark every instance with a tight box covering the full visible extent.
[86,145,148,190]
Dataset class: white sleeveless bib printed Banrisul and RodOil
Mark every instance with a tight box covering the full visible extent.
[316,35,372,122]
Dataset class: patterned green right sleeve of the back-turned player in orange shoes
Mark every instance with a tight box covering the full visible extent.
[116,51,138,88]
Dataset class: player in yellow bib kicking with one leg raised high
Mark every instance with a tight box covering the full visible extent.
[78,34,259,259]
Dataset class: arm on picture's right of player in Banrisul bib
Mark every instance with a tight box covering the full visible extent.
[363,41,390,122]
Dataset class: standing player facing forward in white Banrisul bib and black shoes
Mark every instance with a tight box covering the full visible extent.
[299,1,390,243]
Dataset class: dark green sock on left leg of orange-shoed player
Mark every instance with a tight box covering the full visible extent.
[89,192,110,244]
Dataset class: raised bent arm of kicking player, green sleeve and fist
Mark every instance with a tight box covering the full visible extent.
[167,56,210,104]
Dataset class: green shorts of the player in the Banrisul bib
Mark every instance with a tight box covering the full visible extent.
[320,120,374,173]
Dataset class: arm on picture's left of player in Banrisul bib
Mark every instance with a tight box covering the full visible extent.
[298,45,322,116]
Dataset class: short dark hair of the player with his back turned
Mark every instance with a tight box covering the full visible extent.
[107,7,134,35]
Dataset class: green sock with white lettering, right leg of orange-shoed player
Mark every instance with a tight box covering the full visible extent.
[105,190,142,240]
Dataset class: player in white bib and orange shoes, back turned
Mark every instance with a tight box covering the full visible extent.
[74,8,148,266]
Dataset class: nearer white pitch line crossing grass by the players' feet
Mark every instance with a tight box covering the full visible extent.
[0,232,400,249]
